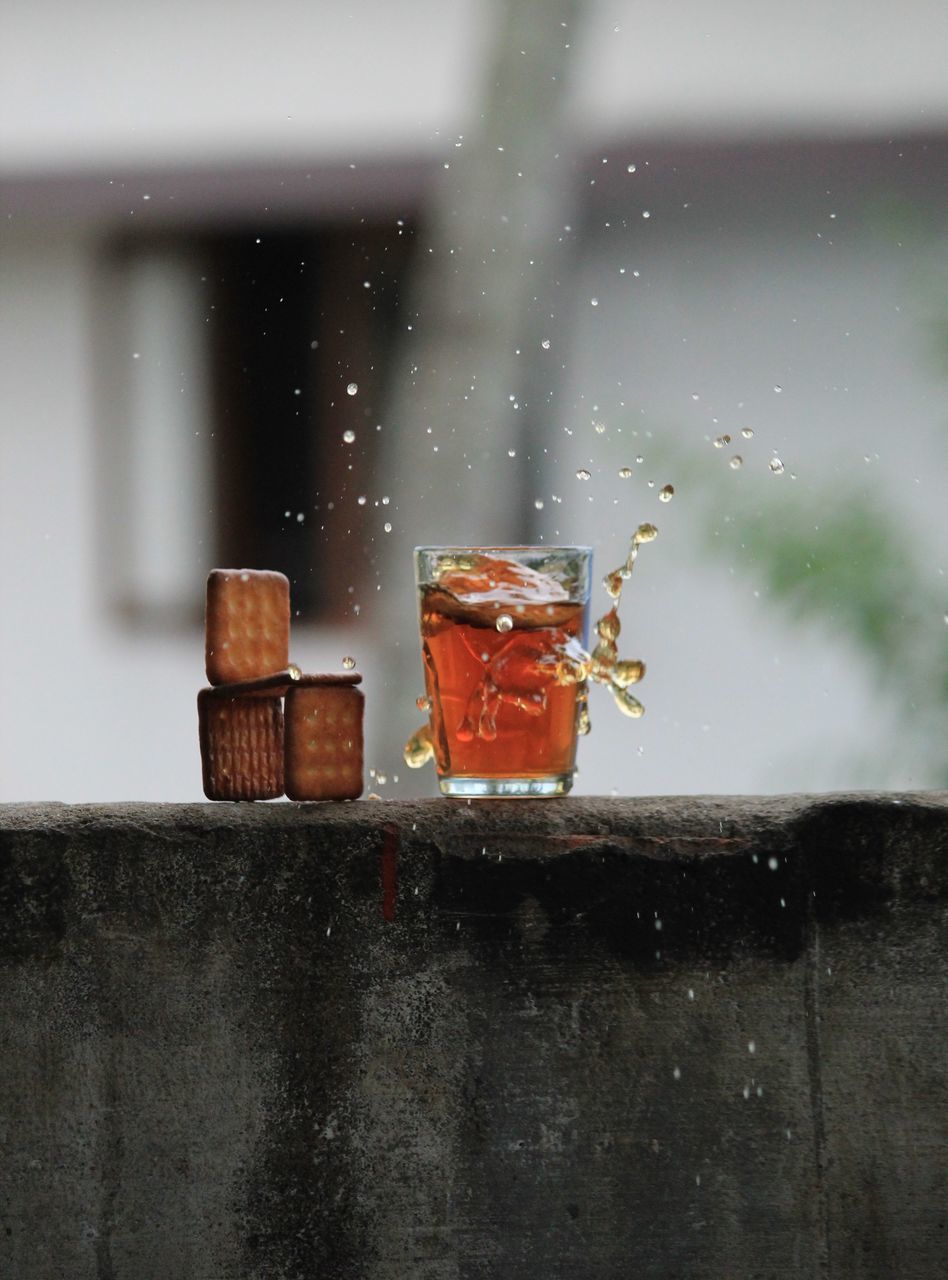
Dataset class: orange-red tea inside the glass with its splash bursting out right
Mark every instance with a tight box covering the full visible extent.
[404,524,658,776]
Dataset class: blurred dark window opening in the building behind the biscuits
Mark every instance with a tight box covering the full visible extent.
[208,225,411,621]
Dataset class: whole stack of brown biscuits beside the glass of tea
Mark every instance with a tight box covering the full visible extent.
[197,568,365,800]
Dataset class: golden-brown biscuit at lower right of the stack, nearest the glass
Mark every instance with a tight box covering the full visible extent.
[285,676,365,800]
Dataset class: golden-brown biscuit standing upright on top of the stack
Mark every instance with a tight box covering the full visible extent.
[205,568,289,685]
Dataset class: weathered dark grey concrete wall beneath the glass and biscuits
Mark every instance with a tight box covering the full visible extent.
[0,795,948,1280]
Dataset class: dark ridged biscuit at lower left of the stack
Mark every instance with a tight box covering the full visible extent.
[197,689,283,800]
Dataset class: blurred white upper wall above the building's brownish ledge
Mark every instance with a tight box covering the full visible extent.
[0,0,948,172]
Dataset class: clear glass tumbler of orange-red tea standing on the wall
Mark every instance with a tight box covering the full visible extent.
[415,547,592,796]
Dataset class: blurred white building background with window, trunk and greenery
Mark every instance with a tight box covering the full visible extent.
[0,0,948,801]
